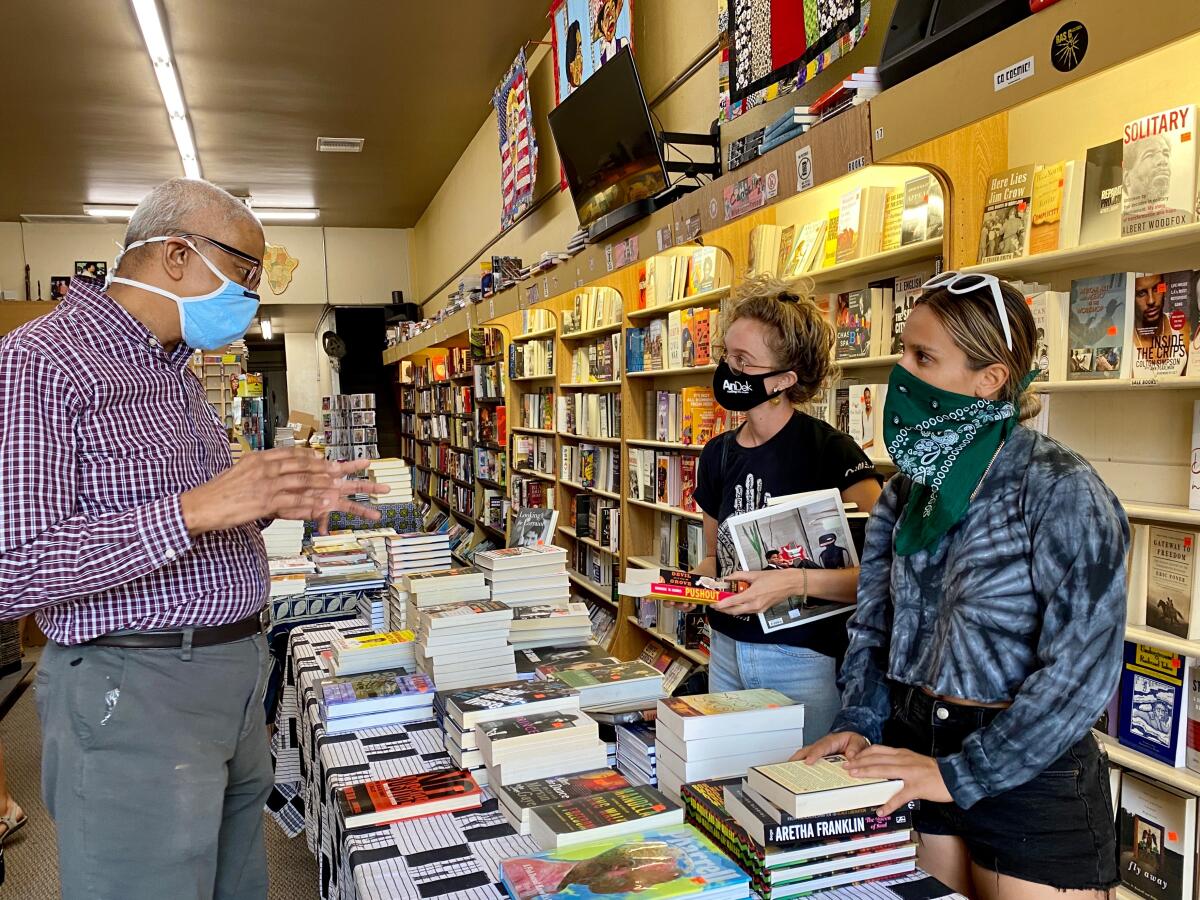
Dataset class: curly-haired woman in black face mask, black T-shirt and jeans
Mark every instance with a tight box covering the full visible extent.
[695,278,880,739]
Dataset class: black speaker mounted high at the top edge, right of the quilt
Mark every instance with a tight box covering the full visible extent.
[880,0,1031,88]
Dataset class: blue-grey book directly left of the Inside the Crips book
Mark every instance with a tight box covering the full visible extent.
[1067,272,1134,382]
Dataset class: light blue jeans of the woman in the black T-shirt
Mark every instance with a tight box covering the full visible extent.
[708,630,841,744]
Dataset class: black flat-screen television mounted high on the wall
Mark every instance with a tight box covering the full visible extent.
[550,47,667,228]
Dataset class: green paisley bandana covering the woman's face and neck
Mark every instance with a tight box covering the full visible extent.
[883,366,1037,556]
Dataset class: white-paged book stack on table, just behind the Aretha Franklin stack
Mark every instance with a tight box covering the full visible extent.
[655,688,804,797]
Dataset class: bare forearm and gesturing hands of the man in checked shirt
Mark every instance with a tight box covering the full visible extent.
[180,448,390,538]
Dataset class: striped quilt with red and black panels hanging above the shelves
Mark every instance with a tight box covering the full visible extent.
[718,0,871,121]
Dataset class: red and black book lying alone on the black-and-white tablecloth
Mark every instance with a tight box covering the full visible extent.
[337,769,482,828]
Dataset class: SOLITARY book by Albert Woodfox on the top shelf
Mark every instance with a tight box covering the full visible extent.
[1121,104,1196,236]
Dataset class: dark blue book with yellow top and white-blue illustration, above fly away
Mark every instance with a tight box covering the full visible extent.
[1117,641,1188,767]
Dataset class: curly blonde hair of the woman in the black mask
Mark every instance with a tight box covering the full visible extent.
[716,275,834,404]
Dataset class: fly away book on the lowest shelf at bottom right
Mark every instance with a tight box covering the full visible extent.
[1117,772,1196,900]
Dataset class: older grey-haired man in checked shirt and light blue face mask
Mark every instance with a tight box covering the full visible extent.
[0,179,382,900]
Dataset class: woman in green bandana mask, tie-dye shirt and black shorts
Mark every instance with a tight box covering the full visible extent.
[797,272,1129,900]
